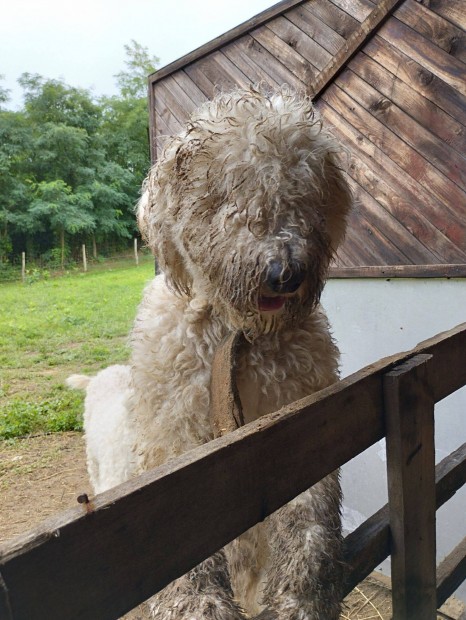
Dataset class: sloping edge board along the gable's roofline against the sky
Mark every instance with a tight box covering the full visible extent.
[149,0,303,84]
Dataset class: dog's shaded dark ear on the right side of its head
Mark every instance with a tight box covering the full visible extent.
[323,152,353,252]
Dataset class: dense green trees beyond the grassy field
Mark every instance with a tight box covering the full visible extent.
[0,41,158,263]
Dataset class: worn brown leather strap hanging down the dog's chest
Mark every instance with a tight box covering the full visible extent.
[210,332,244,437]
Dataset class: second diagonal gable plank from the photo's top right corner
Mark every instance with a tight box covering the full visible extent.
[394,0,466,62]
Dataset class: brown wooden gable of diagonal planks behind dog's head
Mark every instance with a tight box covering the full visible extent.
[149,0,466,277]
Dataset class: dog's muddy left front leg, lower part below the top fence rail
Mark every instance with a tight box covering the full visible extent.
[150,551,245,620]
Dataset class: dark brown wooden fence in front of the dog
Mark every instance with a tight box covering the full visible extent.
[0,324,466,620]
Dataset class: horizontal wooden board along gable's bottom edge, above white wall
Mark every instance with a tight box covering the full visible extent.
[329,264,466,280]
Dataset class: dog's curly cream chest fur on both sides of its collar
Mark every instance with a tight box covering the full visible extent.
[129,277,338,468]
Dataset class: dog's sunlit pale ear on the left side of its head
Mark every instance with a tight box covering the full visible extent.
[136,183,192,297]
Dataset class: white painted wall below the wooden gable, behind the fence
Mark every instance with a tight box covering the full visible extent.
[322,279,466,602]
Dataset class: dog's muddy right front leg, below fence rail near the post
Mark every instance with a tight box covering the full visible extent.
[264,472,342,620]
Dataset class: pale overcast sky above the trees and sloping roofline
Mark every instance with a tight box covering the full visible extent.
[0,0,277,108]
